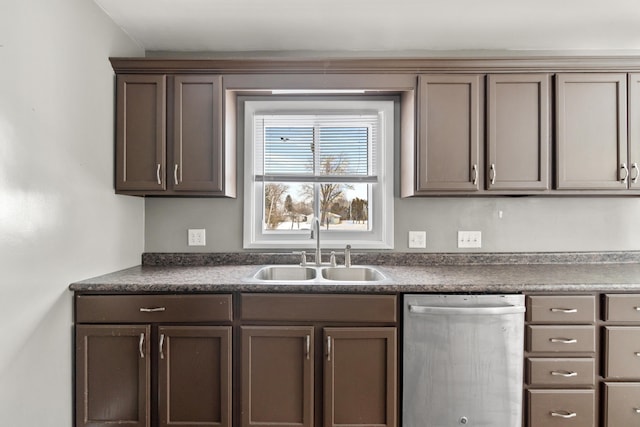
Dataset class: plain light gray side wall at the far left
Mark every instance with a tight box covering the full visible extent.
[0,0,144,427]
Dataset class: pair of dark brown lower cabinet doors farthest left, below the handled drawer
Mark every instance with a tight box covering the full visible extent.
[76,325,231,427]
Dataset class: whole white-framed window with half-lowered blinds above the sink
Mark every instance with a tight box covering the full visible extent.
[240,96,395,249]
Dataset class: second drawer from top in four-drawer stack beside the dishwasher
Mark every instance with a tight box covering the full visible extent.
[527,325,596,353]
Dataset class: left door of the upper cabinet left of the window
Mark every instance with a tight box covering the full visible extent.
[116,74,166,190]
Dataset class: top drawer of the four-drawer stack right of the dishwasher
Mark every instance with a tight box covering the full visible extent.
[527,295,596,324]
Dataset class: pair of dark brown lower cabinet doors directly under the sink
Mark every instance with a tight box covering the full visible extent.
[241,326,397,427]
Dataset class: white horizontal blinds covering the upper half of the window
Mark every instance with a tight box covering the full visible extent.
[254,111,380,182]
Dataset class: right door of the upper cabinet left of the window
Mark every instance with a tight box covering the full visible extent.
[169,76,224,192]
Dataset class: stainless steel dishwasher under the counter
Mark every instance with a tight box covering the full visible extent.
[402,295,525,427]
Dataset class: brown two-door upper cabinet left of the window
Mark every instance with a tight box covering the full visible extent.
[116,74,236,197]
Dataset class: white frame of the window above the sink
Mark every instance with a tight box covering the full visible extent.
[238,96,398,249]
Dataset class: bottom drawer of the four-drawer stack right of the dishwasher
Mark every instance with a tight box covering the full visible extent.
[528,390,595,427]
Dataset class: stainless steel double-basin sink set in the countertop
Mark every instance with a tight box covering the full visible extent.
[251,265,387,284]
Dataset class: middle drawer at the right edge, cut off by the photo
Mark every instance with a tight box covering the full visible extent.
[604,326,640,378]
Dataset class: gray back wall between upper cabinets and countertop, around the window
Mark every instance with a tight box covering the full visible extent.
[145,108,640,252]
